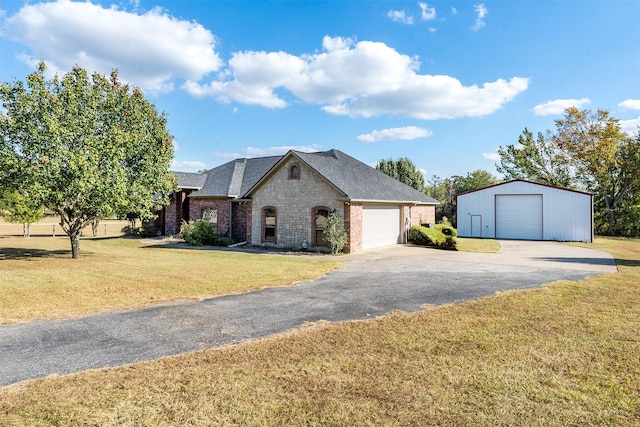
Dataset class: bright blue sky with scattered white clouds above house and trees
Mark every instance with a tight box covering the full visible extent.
[0,0,640,178]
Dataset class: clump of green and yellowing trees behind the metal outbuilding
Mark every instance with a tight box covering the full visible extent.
[496,107,640,234]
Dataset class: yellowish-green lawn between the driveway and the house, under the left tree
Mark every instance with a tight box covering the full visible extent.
[0,237,343,324]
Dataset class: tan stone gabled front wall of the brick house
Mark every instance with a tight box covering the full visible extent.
[249,158,344,249]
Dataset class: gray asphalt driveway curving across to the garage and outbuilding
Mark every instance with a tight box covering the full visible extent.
[0,241,617,386]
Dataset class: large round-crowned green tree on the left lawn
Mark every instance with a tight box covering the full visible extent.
[0,62,175,258]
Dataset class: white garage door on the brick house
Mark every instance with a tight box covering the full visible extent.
[362,205,400,249]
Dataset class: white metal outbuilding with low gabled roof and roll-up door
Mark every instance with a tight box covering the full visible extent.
[457,179,593,242]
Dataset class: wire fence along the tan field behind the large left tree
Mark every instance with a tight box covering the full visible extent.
[0,217,129,237]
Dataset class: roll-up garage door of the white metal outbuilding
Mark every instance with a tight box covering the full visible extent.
[496,194,542,240]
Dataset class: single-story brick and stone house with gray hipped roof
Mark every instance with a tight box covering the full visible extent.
[156,150,438,252]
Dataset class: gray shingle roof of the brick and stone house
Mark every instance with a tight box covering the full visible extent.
[179,150,438,204]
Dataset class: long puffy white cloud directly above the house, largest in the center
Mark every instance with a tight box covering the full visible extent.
[189,36,529,119]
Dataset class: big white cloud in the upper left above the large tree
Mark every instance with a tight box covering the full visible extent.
[3,0,222,92]
